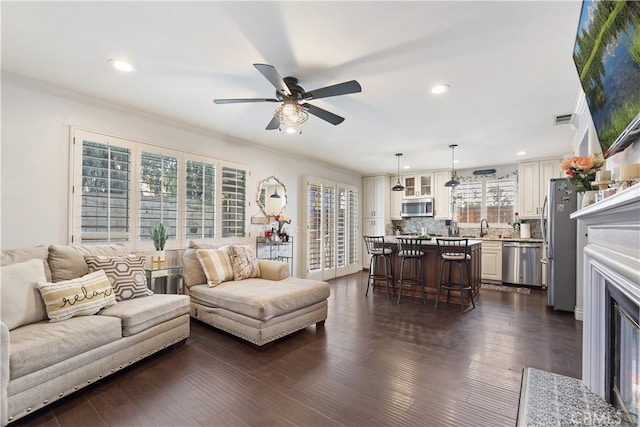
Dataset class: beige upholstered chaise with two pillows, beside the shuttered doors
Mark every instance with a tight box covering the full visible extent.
[183,242,330,346]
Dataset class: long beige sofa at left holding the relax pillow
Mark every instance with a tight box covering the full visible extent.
[0,245,190,426]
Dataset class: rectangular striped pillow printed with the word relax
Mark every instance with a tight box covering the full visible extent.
[36,270,116,322]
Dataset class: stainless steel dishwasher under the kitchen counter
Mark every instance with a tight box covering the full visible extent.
[502,242,542,286]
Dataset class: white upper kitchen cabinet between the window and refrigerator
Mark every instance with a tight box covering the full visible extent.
[518,159,562,219]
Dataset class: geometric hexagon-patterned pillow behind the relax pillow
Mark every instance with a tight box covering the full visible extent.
[84,255,153,301]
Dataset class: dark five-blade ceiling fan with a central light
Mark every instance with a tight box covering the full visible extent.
[213,64,362,130]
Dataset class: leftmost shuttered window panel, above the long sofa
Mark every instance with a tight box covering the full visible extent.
[72,139,132,243]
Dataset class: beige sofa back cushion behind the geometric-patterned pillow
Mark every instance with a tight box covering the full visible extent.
[49,243,129,282]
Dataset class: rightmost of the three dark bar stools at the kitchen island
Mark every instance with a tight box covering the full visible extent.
[435,239,476,311]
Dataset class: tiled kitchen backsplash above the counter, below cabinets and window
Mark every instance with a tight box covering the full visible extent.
[386,217,542,239]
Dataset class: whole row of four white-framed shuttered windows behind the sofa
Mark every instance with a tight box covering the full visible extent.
[68,129,249,251]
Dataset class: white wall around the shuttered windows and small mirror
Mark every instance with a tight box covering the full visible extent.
[0,76,362,260]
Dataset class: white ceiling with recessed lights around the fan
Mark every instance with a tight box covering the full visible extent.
[1,0,581,174]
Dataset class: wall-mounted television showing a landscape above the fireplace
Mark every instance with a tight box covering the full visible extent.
[573,0,640,158]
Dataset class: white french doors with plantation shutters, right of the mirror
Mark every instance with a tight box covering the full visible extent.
[304,177,360,280]
